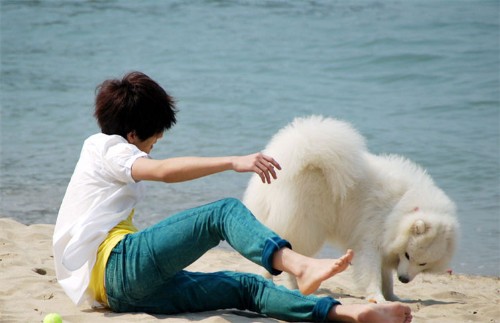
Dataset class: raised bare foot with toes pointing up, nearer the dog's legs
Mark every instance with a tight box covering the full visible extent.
[296,249,354,295]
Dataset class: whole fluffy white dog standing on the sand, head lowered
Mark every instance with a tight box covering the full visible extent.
[243,116,458,302]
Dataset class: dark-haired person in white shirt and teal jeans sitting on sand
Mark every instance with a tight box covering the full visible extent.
[53,72,411,322]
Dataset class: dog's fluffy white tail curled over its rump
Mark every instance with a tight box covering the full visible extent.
[265,116,366,200]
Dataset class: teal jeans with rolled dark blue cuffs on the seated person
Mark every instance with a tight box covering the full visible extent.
[105,198,340,322]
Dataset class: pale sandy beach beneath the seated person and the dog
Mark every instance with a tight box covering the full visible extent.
[0,217,500,322]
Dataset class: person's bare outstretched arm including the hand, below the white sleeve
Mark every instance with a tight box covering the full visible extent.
[132,153,281,183]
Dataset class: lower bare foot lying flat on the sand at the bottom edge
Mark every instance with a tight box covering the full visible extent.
[328,303,413,323]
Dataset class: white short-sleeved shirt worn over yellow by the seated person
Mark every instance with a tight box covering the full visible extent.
[53,133,148,305]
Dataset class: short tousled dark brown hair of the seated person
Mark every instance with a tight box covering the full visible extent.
[94,72,177,140]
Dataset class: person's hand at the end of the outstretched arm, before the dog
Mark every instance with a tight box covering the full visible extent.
[233,153,281,184]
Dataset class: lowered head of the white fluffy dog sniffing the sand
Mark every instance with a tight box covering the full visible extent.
[397,211,458,283]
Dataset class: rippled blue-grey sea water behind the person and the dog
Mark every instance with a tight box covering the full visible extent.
[0,0,500,276]
